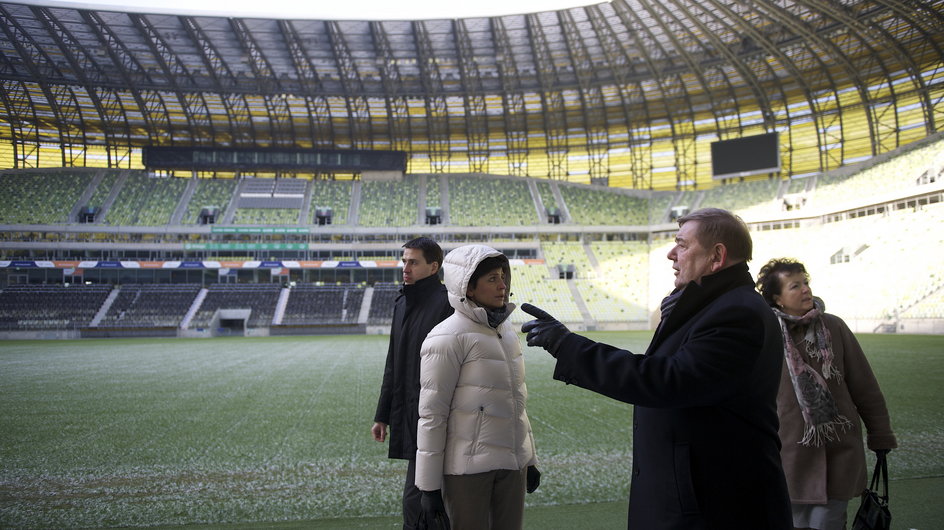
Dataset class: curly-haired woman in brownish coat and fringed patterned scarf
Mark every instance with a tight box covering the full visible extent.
[757,259,898,530]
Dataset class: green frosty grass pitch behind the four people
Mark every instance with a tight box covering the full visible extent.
[0,332,944,530]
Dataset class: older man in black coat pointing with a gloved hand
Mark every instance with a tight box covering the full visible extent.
[522,208,793,530]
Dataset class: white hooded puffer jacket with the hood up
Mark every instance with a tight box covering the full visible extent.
[416,245,536,491]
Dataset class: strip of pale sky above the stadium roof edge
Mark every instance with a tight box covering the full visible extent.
[24,0,604,20]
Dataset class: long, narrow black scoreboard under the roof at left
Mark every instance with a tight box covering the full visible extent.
[142,146,406,172]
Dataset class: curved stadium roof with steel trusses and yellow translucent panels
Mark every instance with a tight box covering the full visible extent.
[0,0,944,188]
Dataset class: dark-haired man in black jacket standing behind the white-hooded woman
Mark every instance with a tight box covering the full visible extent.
[371,237,453,530]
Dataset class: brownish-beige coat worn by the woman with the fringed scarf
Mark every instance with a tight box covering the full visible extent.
[777,314,898,504]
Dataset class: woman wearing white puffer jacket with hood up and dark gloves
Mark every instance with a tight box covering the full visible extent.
[416,245,540,530]
